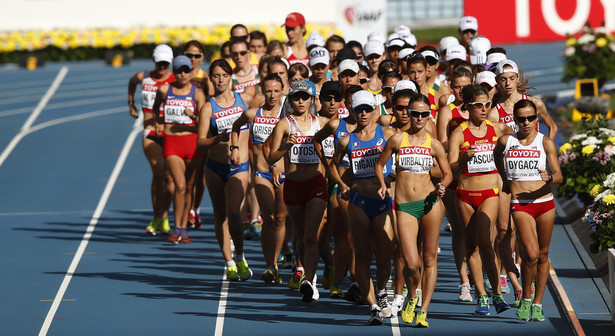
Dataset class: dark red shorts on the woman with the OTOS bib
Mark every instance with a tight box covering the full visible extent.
[284,174,329,205]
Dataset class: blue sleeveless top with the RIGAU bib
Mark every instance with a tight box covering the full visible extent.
[347,125,392,180]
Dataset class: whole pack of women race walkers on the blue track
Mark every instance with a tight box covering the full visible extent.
[128,13,562,327]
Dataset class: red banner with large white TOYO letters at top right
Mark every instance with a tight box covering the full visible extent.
[464,0,615,43]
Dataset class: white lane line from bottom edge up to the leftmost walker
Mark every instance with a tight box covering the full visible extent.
[39,116,143,336]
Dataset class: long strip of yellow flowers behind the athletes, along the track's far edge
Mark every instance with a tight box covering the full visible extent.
[0,24,341,53]
